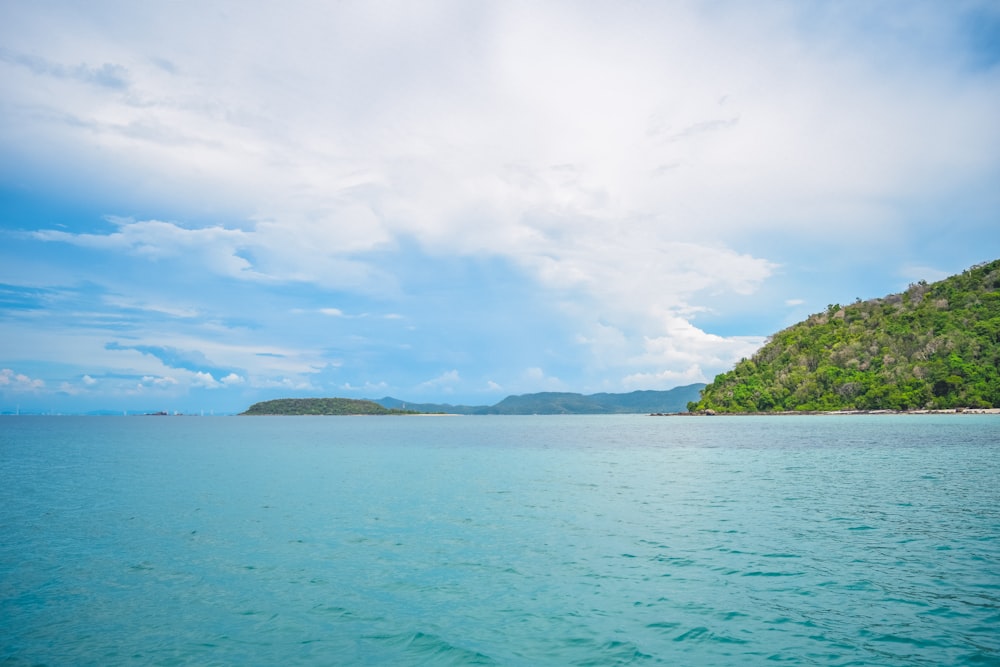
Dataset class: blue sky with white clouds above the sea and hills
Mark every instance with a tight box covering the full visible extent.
[0,0,1000,414]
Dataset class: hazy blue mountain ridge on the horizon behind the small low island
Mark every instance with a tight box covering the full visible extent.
[372,383,705,415]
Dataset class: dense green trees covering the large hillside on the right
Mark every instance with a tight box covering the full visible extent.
[688,260,1000,412]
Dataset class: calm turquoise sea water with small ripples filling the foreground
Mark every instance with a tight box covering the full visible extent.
[0,415,1000,665]
